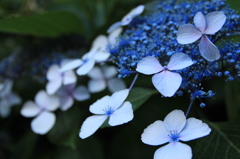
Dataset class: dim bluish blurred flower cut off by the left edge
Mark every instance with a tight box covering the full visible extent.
[0,80,22,118]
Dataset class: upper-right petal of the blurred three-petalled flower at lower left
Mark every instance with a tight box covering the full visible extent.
[35,90,60,111]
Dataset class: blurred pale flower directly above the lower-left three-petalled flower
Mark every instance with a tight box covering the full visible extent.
[46,61,77,95]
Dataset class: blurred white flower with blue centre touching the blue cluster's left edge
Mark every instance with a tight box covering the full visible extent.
[61,35,110,75]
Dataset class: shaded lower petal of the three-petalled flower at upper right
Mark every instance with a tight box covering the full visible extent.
[199,35,221,61]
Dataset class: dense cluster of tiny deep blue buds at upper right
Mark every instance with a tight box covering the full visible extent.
[108,0,240,98]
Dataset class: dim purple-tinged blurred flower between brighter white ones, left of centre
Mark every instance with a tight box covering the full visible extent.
[56,83,90,111]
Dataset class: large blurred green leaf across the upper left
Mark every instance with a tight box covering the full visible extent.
[0,11,82,37]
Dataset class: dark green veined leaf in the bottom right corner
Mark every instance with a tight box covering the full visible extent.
[193,121,240,159]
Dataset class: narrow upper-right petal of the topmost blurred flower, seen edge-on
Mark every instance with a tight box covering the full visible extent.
[122,5,145,26]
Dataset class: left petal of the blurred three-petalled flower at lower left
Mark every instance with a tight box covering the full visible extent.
[20,101,41,117]
